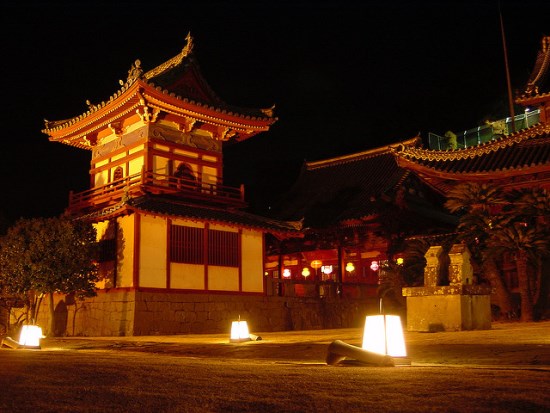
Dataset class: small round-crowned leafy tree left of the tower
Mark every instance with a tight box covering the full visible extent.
[0,218,98,334]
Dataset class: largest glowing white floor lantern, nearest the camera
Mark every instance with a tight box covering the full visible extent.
[362,314,407,357]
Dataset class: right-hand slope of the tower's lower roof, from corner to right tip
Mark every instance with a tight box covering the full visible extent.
[127,195,300,234]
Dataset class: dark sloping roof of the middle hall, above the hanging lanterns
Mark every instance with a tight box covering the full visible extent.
[272,138,458,228]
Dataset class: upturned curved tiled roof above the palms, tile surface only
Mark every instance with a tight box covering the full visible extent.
[395,123,550,175]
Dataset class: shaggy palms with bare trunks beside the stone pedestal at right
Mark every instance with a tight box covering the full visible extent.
[445,182,550,321]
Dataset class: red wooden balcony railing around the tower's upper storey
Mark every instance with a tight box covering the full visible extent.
[68,168,246,213]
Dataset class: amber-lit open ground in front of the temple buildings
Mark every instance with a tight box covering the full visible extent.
[0,322,550,412]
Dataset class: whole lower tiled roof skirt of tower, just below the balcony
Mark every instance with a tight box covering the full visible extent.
[79,195,301,237]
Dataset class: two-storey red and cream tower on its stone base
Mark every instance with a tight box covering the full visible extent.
[43,36,304,335]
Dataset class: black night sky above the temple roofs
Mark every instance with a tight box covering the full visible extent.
[0,0,550,220]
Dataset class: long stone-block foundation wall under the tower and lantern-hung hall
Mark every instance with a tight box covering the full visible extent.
[38,291,379,336]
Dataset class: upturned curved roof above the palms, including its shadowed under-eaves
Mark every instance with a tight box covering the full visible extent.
[392,123,550,193]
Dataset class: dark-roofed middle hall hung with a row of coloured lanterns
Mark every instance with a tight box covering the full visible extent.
[266,138,456,299]
